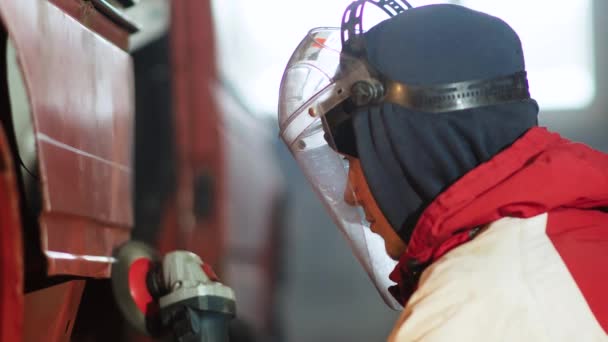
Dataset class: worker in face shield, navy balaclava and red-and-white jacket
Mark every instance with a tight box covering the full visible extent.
[279,0,608,342]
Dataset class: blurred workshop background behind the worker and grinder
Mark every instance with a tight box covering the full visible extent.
[91,0,608,342]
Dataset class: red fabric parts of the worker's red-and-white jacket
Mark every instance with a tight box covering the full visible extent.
[391,128,608,340]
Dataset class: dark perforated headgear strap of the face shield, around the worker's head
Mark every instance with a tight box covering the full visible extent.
[340,0,530,113]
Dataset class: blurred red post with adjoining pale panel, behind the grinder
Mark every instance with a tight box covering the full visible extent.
[158,1,283,336]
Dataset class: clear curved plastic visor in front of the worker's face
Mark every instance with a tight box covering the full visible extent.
[279,28,401,309]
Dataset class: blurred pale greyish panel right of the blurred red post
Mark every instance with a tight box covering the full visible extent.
[216,86,284,336]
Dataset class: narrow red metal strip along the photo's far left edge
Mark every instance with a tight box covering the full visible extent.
[0,129,23,341]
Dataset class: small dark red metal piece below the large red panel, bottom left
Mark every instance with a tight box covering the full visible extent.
[23,280,85,342]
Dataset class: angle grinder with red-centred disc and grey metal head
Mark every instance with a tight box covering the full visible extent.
[112,241,236,342]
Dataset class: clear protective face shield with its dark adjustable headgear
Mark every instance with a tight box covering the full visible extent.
[279,0,529,309]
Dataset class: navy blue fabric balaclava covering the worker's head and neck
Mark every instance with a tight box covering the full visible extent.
[352,5,538,243]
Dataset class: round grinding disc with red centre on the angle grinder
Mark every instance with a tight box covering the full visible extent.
[112,241,160,336]
